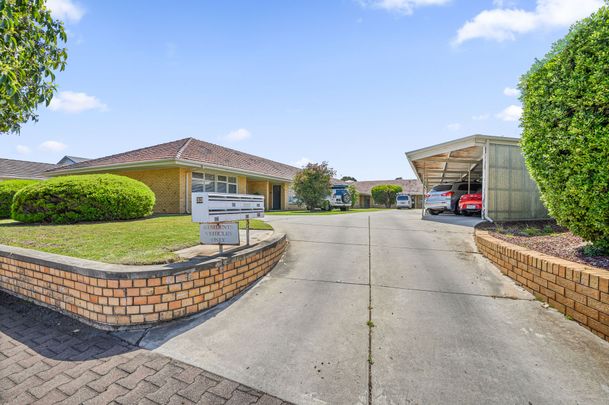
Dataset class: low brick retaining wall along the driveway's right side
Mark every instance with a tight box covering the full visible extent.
[475,230,609,341]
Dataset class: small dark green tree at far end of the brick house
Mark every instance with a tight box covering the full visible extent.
[292,162,336,211]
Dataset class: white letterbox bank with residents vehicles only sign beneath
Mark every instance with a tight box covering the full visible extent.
[192,193,264,252]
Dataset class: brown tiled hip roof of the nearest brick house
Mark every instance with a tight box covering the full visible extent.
[51,138,299,179]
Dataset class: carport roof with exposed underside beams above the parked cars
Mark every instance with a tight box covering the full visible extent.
[406,135,520,189]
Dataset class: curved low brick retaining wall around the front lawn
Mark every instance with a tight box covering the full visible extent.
[0,234,287,330]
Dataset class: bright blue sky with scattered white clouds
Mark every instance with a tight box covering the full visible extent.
[0,0,602,180]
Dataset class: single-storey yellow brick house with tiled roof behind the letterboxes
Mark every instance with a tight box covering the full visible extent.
[46,138,298,214]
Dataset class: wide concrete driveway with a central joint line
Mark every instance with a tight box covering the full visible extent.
[141,211,609,404]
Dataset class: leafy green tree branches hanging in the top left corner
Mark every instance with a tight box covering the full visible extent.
[0,0,68,134]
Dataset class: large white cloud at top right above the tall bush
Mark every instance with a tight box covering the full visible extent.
[454,0,604,45]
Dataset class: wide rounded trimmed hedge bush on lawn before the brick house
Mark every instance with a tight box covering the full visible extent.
[11,174,155,224]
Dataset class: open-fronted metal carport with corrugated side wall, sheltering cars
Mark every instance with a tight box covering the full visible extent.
[406,135,547,221]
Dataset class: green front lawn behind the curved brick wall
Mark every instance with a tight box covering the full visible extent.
[0,215,273,264]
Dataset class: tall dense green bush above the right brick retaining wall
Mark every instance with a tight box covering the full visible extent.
[520,6,609,248]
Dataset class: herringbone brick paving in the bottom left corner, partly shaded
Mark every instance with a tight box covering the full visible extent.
[0,292,287,405]
